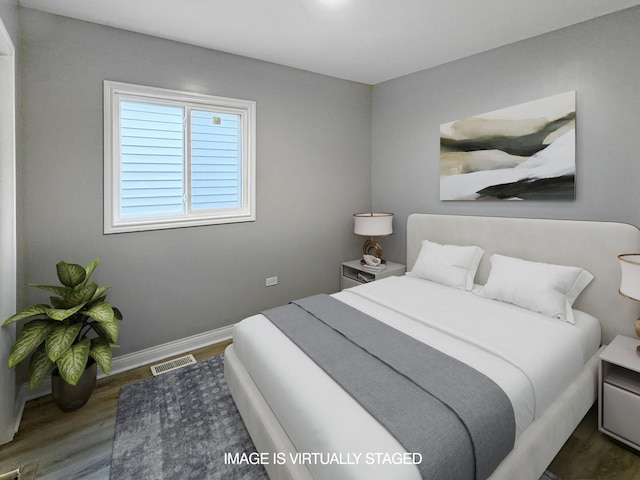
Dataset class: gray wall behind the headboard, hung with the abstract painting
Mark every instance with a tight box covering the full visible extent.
[372,7,640,261]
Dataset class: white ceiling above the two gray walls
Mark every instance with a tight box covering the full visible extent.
[19,0,640,85]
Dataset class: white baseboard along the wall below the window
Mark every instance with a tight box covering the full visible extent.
[16,325,233,406]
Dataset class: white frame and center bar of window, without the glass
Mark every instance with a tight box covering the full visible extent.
[104,80,256,234]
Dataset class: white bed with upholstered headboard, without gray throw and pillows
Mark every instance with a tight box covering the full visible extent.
[225,214,640,480]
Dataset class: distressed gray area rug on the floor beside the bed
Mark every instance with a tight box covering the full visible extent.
[110,355,559,480]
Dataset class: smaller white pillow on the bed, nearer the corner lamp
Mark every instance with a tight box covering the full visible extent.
[407,240,484,290]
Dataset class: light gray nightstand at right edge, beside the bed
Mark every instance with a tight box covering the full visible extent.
[598,335,640,450]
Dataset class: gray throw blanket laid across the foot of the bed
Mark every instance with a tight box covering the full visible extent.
[263,295,515,480]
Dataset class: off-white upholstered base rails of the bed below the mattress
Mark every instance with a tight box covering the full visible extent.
[224,344,604,480]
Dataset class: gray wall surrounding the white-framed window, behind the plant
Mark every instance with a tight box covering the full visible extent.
[19,9,371,355]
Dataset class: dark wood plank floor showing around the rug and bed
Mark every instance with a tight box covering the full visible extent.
[0,342,640,480]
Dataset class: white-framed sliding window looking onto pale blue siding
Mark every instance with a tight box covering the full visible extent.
[104,81,255,233]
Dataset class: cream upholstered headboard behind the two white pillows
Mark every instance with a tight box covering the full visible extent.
[407,214,640,344]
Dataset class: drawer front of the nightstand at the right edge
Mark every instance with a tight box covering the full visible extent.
[602,383,640,445]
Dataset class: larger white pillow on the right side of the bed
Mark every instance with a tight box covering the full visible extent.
[478,254,593,323]
